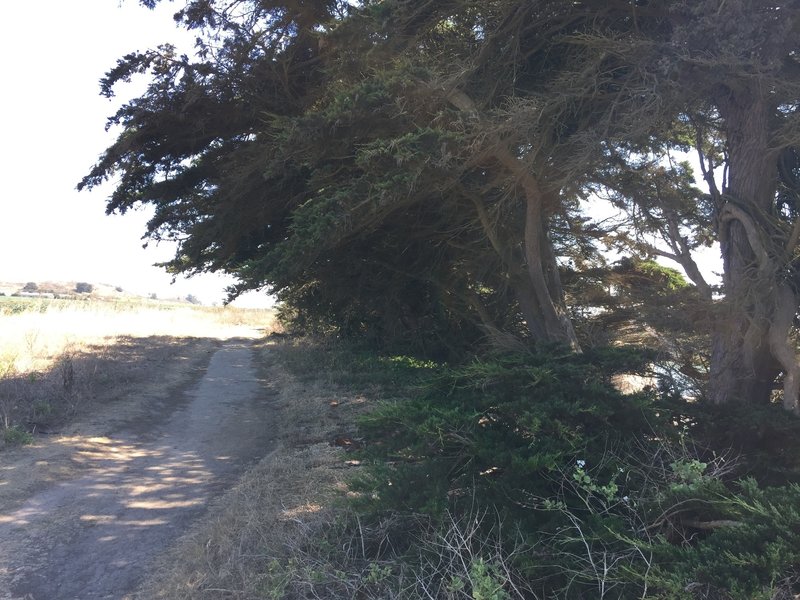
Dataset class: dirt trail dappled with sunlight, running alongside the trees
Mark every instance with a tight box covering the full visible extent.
[0,340,274,600]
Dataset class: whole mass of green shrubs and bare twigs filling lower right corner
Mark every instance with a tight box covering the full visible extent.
[348,348,800,600]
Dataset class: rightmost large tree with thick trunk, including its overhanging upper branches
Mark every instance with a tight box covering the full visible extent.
[450,0,800,411]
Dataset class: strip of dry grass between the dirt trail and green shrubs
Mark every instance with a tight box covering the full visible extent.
[136,342,374,600]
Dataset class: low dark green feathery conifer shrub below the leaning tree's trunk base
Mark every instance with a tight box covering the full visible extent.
[360,348,666,514]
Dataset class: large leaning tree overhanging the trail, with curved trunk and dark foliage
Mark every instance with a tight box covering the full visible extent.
[83,3,600,348]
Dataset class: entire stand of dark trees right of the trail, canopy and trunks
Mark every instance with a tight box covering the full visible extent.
[80,0,800,411]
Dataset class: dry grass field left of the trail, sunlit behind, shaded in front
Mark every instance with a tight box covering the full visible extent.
[0,297,274,447]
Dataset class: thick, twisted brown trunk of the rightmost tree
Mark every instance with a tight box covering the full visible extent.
[708,90,797,409]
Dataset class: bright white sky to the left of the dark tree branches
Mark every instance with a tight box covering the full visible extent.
[0,0,274,305]
